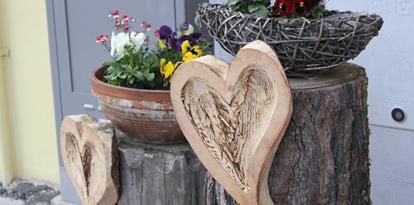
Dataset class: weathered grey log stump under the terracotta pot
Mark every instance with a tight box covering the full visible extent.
[117,135,212,205]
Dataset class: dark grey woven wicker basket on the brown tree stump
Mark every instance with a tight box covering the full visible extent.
[197,3,383,77]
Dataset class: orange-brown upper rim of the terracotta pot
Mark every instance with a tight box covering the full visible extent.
[90,66,171,102]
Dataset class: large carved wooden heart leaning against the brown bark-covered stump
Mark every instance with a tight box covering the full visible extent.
[171,41,292,205]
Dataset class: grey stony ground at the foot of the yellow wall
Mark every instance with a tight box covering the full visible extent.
[0,179,59,205]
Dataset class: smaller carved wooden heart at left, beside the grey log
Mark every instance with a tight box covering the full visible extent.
[60,115,118,205]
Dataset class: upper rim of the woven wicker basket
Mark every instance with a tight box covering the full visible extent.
[197,3,382,24]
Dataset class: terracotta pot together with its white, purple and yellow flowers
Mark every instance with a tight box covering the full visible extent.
[90,11,208,144]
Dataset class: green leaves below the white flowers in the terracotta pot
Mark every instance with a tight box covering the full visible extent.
[104,46,162,89]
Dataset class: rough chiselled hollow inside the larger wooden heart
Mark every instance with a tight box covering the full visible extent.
[182,67,277,192]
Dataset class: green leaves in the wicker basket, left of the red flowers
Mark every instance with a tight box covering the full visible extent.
[228,0,271,16]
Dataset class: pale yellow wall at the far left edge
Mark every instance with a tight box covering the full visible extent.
[0,0,59,184]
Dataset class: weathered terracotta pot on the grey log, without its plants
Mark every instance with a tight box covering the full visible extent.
[90,67,186,144]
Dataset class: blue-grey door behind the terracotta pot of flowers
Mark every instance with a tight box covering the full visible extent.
[46,0,207,202]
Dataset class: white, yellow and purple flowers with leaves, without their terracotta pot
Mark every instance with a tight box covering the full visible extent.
[95,13,209,89]
